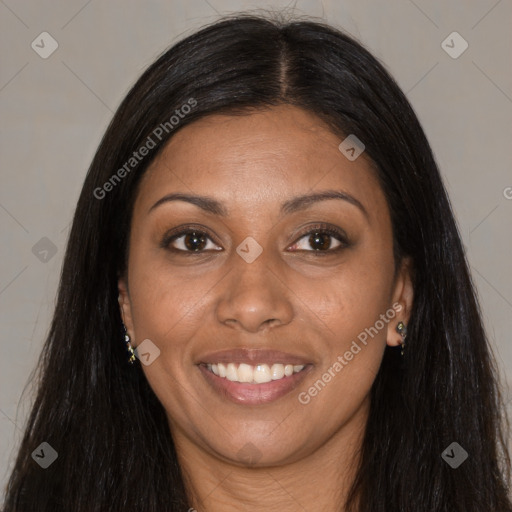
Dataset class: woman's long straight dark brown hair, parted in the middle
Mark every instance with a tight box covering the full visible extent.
[4,14,512,512]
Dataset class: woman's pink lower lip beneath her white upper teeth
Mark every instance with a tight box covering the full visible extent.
[198,364,312,405]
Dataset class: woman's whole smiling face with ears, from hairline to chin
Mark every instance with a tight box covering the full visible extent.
[119,106,412,465]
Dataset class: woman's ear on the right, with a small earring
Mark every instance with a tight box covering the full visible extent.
[387,258,414,347]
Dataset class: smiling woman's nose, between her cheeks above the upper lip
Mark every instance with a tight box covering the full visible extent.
[216,251,294,333]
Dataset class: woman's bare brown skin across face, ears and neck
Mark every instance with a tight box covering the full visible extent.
[119,106,413,512]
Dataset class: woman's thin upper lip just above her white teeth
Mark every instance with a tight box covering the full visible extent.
[197,348,311,366]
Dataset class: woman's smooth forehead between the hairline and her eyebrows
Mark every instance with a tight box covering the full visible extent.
[137,105,386,220]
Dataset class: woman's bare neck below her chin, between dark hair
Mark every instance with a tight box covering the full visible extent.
[173,404,368,512]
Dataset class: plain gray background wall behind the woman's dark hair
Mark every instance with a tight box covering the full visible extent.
[0,0,512,495]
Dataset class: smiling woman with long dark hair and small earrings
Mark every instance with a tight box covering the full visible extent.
[5,15,512,512]
